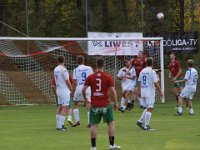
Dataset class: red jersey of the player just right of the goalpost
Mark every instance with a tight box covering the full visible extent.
[169,60,182,77]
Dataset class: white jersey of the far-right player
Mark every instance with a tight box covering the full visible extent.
[184,68,198,89]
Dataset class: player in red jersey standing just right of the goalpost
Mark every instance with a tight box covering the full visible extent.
[169,52,183,102]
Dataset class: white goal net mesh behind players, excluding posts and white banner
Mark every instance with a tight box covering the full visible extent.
[0,40,161,104]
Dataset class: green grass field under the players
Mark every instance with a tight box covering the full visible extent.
[0,101,200,150]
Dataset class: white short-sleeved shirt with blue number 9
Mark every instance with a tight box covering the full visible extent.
[73,65,93,86]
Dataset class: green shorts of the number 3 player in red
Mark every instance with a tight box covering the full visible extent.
[90,105,114,125]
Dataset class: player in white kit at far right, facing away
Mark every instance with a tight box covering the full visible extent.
[175,59,198,116]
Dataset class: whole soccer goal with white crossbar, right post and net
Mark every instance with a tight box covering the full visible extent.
[0,37,165,104]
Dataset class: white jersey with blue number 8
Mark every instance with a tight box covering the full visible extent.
[138,67,158,97]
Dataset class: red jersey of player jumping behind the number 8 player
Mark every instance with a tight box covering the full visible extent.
[132,59,146,77]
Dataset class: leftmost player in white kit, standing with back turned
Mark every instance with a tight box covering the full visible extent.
[54,56,73,130]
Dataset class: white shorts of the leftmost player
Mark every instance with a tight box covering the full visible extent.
[56,90,70,106]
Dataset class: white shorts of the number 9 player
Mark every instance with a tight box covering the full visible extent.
[74,86,91,102]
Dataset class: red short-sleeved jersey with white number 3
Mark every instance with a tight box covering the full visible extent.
[84,71,114,107]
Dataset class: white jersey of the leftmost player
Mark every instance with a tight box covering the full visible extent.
[54,65,70,93]
